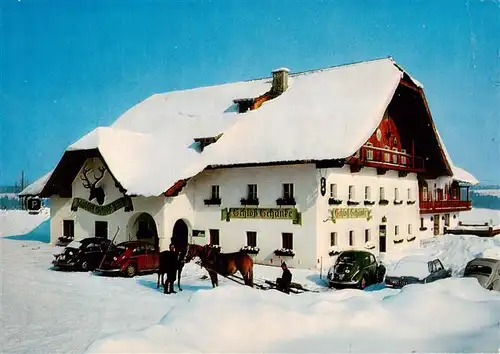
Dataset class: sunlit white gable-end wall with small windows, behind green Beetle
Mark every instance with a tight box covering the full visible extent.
[317,166,420,259]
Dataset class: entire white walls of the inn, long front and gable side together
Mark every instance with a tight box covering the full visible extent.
[51,158,472,268]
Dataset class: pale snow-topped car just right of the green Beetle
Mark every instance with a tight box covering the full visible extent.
[385,256,451,289]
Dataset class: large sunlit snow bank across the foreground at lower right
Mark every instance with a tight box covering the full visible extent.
[87,279,500,353]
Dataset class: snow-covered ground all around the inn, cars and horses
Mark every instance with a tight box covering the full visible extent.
[0,212,500,353]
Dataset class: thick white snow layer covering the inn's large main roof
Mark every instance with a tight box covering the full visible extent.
[23,58,476,196]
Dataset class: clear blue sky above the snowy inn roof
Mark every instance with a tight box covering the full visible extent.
[0,0,500,185]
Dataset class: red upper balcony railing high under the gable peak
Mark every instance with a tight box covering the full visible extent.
[356,145,425,171]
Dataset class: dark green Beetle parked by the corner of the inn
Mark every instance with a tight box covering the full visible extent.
[327,250,385,289]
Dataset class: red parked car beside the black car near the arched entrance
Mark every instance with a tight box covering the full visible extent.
[96,241,159,277]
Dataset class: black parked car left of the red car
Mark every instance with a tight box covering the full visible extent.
[52,237,111,271]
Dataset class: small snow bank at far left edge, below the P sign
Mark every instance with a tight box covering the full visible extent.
[0,208,50,237]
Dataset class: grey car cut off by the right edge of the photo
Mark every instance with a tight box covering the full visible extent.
[464,258,500,291]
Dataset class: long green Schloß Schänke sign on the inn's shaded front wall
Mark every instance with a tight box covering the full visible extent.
[221,208,302,225]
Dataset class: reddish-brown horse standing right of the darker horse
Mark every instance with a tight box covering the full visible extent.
[200,245,253,288]
